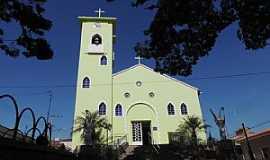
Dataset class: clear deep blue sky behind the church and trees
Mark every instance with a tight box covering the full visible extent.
[0,0,270,137]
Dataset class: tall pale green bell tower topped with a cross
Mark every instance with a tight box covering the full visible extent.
[72,9,116,146]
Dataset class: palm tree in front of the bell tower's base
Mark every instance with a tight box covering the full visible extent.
[73,110,112,146]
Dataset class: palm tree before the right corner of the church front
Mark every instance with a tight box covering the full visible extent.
[177,116,209,146]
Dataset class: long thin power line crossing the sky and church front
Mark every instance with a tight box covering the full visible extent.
[0,71,270,89]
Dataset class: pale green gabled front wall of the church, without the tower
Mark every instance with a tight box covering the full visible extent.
[113,65,206,144]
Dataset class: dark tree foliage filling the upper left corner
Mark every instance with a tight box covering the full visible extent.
[0,0,53,60]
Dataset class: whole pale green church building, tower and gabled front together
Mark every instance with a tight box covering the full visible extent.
[72,14,206,146]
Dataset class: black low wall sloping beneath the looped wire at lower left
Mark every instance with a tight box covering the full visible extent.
[0,138,75,160]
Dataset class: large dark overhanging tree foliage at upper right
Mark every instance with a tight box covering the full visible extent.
[107,0,270,76]
